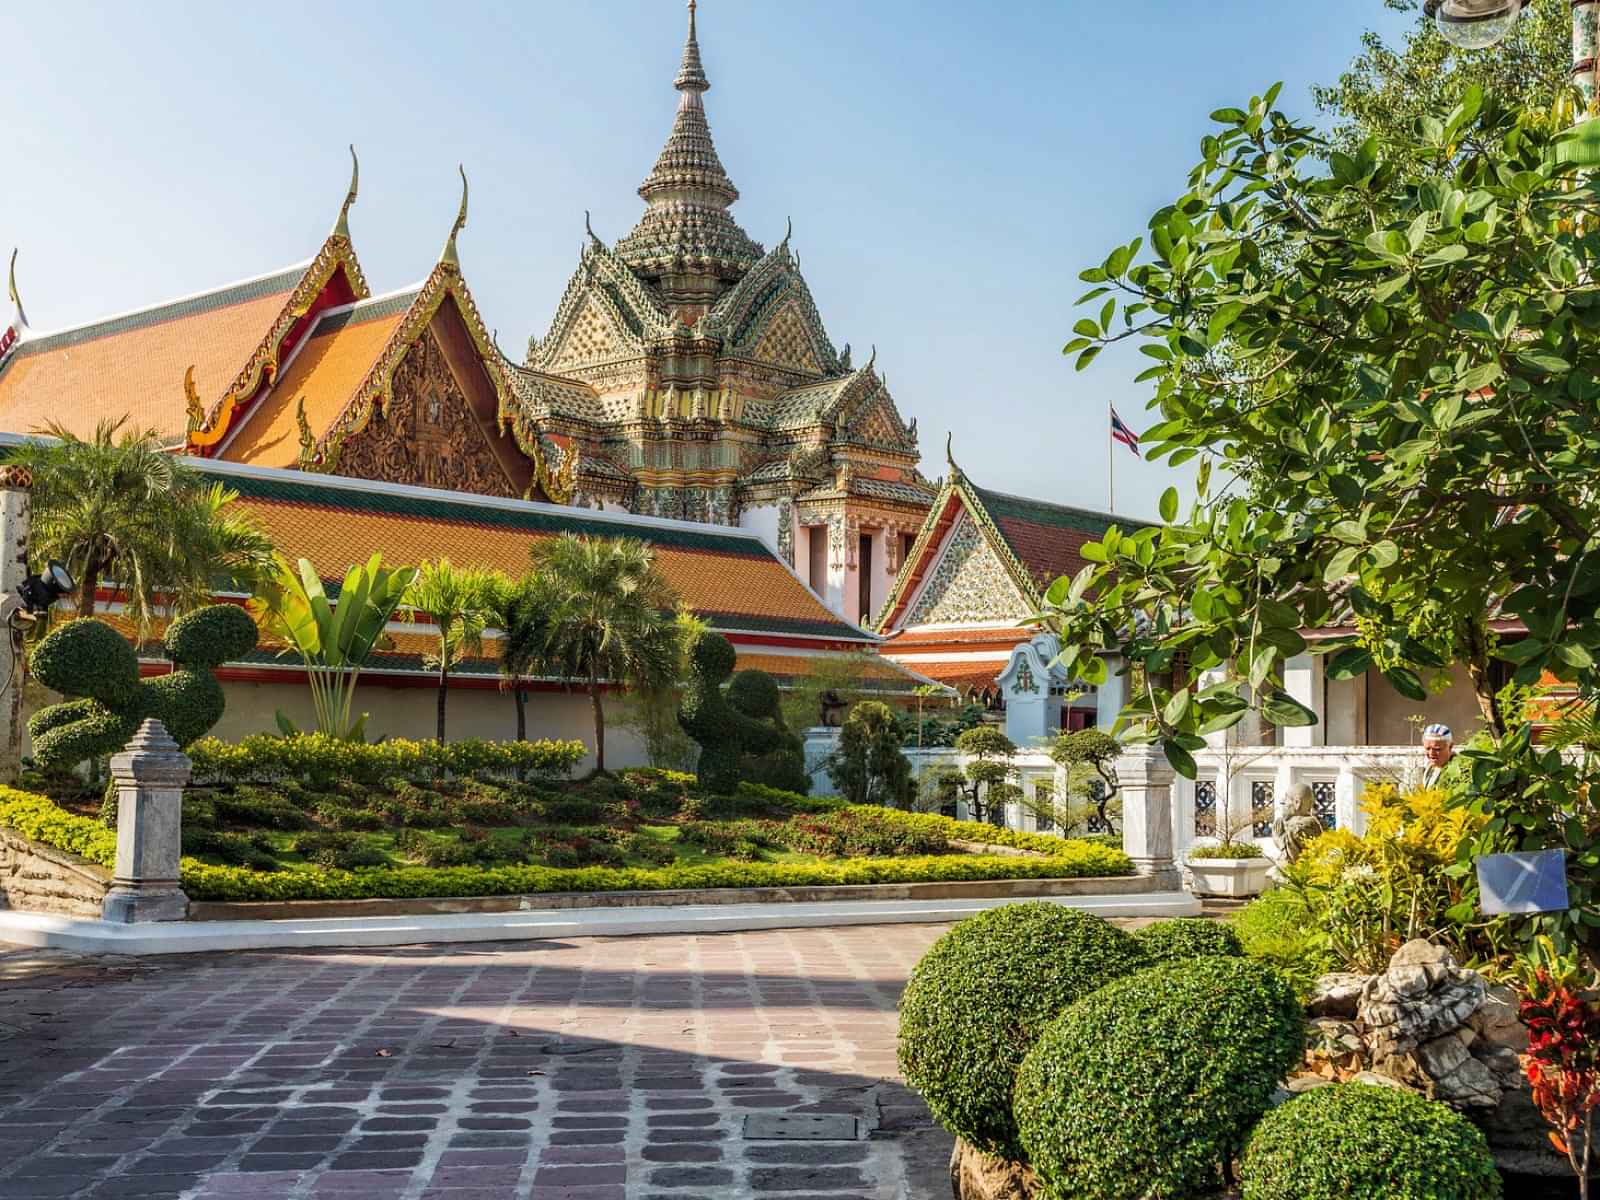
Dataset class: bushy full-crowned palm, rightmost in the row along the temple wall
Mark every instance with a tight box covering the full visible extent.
[533,533,678,771]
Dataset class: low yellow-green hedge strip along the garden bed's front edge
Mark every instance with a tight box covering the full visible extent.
[182,854,1098,901]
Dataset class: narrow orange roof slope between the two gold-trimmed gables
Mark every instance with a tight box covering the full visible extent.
[222,291,418,467]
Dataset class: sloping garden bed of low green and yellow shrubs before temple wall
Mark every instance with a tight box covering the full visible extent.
[0,755,1133,902]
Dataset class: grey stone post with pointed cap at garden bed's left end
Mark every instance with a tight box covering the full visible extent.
[101,717,189,925]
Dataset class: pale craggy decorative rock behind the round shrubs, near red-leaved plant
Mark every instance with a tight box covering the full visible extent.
[1357,939,1488,1059]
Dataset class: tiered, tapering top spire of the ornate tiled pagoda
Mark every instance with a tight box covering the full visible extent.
[616,0,762,315]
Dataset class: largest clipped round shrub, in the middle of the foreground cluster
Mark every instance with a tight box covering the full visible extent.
[1014,958,1306,1200]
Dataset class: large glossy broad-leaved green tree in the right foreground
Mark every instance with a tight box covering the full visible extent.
[1046,80,1600,939]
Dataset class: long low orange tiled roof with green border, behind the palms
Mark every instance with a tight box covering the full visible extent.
[195,462,872,643]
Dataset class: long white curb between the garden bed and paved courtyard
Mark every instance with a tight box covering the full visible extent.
[0,891,1200,954]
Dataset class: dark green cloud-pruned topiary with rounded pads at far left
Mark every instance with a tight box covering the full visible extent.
[27,605,258,766]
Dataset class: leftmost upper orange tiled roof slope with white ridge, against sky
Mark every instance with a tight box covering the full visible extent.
[0,264,306,442]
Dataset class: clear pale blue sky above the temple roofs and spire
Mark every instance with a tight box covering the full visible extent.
[0,0,1405,515]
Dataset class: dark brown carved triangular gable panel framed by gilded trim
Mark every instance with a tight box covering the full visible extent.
[334,333,518,498]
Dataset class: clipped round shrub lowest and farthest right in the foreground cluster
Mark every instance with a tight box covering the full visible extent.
[1240,1083,1501,1200]
